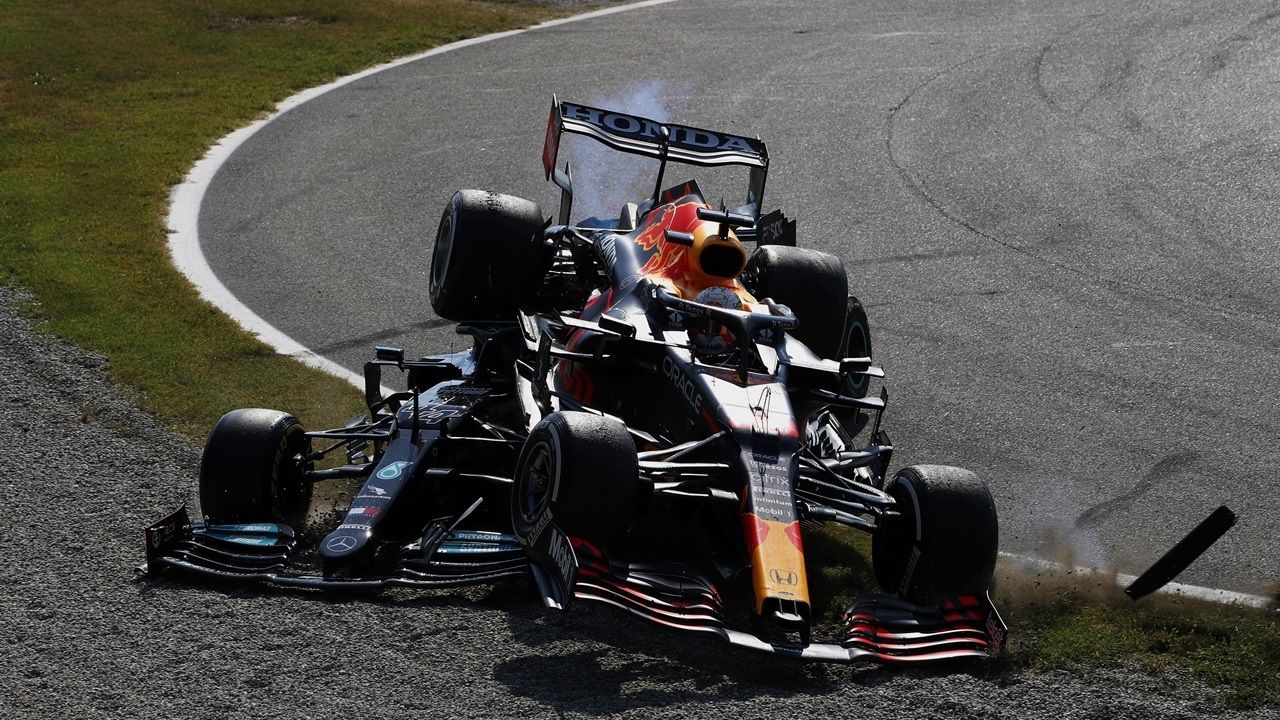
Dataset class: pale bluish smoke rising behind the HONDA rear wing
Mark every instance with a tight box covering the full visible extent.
[559,81,689,222]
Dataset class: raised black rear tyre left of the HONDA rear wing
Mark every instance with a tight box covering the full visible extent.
[430,190,552,322]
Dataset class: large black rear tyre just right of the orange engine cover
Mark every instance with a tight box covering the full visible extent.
[744,245,849,359]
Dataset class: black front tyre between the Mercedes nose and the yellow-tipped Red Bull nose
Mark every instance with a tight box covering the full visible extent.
[511,411,640,547]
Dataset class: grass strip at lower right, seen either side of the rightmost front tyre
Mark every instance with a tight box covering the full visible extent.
[805,527,1280,710]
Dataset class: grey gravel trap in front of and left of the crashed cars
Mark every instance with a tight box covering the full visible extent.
[0,287,1264,720]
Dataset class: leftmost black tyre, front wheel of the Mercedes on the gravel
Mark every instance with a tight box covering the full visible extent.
[200,409,311,530]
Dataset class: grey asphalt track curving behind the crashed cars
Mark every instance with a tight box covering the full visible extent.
[200,0,1280,592]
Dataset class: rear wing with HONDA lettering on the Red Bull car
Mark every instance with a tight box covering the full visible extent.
[543,96,769,217]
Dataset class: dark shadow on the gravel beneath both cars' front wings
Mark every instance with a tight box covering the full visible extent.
[138,558,1000,715]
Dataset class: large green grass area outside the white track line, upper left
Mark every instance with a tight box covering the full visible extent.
[0,0,570,439]
